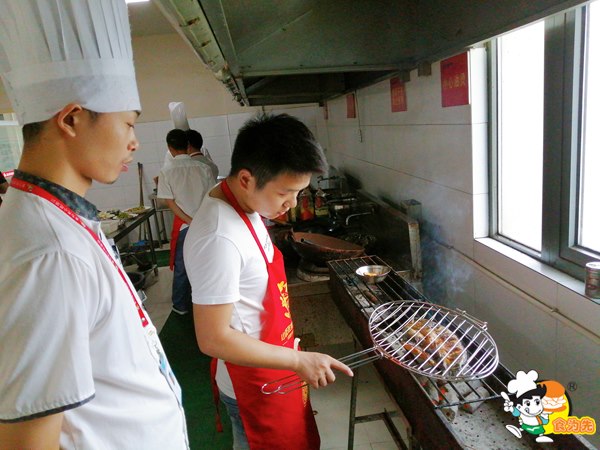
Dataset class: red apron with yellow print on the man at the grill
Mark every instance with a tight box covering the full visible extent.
[221,180,321,450]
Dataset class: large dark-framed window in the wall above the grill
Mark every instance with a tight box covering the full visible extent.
[490,0,600,278]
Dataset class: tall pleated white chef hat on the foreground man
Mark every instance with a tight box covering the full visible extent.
[0,0,141,125]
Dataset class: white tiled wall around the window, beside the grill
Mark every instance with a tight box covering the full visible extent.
[325,49,600,445]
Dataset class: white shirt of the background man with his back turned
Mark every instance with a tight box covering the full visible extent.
[156,155,216,228]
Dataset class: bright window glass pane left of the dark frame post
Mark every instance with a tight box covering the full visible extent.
[498,22,544,251]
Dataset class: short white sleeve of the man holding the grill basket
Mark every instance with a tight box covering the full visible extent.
[183,234,242,305]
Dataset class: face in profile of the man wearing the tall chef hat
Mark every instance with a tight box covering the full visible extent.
[71,111,139,183]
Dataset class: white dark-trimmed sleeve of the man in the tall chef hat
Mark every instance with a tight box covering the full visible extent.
[0,252,99,421]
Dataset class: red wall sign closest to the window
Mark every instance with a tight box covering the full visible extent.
[440,52,469,108]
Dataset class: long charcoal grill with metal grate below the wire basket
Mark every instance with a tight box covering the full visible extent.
[327,256,589,449]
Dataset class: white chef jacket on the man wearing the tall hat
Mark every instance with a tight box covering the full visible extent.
[0,189,188,450]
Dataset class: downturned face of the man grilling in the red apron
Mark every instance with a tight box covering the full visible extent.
[247,173,311,219]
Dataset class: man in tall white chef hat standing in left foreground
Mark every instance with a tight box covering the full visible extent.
[0,0,188,450]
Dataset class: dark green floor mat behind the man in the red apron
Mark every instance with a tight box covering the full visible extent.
[160,313,233,450]
